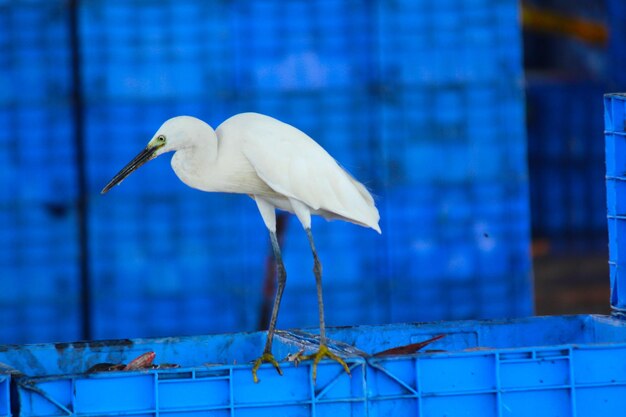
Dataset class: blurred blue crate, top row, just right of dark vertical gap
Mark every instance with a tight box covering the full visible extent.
[79,0,234,103]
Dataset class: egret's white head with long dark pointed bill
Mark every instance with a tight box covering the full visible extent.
[101,116,211,194]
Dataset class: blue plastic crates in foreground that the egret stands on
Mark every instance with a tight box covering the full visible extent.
[0,316,626,417]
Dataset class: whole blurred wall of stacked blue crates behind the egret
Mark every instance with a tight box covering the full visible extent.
[0,0,532,343]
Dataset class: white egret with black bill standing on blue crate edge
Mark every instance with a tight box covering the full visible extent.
[102,113,381,382]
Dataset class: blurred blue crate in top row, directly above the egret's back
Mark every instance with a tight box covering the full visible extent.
[235,0,372,94]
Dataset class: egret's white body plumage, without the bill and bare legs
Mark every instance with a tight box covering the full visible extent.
[163,113,380,233]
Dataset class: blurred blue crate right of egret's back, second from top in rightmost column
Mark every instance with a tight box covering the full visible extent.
[382,83,527,185]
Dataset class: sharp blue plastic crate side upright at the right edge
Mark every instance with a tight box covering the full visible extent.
[604,93,626,318]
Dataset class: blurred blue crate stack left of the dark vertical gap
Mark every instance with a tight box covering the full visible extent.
[0,1,80,342]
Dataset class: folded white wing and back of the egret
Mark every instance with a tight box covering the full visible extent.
[216,113,380,233]
